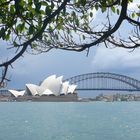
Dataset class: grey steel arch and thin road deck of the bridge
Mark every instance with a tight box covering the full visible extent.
[65,72,140,91]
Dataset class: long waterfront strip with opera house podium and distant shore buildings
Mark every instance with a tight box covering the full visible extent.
[0,94,140,102]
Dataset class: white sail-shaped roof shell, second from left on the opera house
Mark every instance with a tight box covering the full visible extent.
[26,84,38,96]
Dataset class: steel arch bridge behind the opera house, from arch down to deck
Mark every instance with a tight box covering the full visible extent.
[65,72,140,91]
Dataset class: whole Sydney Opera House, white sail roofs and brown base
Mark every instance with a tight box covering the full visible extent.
[9,75,77,101]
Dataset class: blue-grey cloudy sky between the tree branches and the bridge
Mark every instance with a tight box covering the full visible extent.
[0,0,140,89]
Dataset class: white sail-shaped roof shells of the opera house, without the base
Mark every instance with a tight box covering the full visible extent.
[9,75,77,98]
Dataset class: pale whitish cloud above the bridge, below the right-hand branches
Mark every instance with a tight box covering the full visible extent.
[92,47,140,77]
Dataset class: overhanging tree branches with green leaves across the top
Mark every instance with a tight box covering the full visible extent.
[0,0,140,86]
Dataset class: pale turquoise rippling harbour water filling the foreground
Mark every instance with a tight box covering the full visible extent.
[0,102,140,140]
